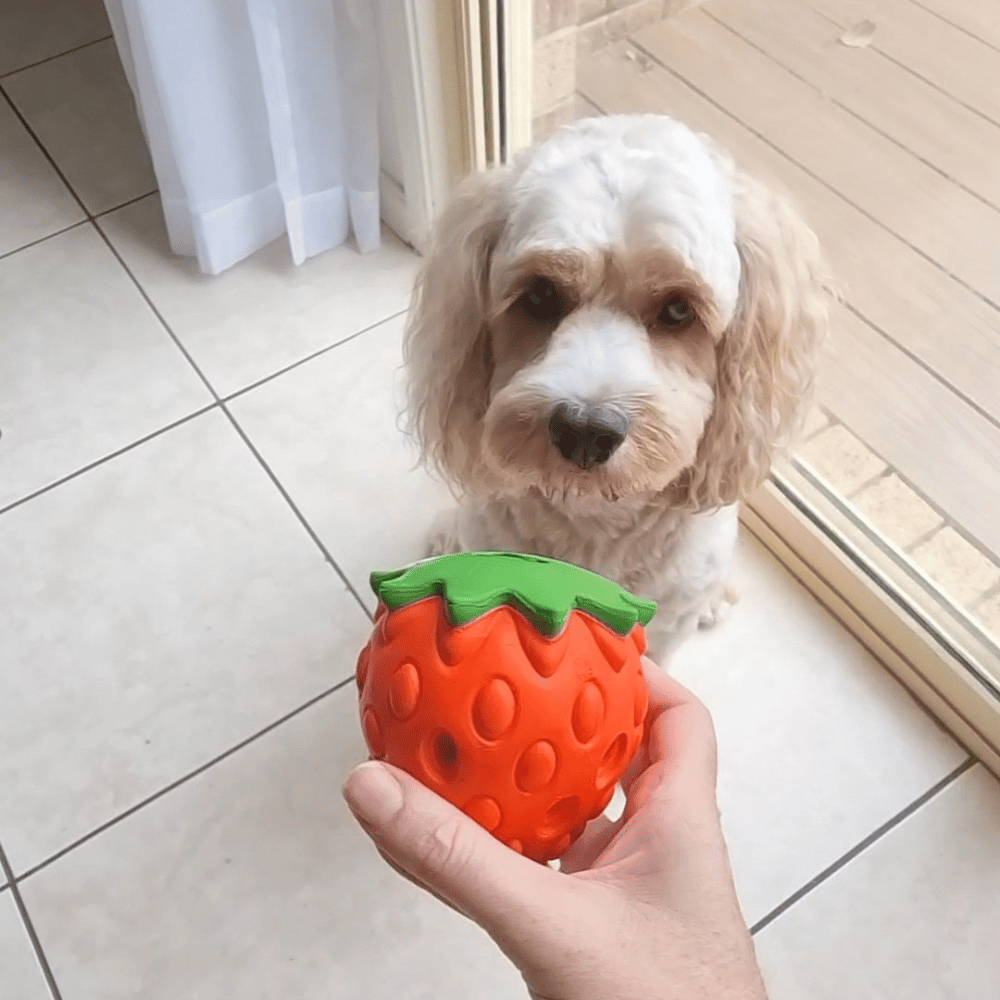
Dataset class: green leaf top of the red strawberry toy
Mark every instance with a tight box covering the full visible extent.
[371,552,656,637]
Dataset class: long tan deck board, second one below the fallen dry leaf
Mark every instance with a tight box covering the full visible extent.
[632,10,1000,306]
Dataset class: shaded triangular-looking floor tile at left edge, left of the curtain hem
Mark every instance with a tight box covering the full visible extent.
[0,98,86,255]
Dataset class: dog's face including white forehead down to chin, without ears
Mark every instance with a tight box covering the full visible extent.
[483,120,739,500]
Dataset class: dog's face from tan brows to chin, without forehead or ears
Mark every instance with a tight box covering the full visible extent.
[483,252,721,500]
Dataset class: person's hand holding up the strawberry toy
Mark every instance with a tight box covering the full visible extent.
[344,658,766,1000]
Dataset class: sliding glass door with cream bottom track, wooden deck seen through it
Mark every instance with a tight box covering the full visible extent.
[501,0,1000,765]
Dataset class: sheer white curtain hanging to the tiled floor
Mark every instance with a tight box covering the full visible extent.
[105,0,379,274]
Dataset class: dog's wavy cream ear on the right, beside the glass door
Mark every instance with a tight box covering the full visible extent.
[681,173,835,509]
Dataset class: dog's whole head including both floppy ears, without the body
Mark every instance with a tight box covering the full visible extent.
[407,116,823,505]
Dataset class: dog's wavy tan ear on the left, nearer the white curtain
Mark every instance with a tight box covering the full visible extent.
[403,168,510,487]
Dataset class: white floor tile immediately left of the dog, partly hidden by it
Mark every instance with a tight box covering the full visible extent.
[230,317,453,610]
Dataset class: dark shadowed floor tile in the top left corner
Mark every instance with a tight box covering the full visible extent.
[0,0,111,76]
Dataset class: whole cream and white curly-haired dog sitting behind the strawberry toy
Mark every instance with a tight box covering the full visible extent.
[404,115,833,664]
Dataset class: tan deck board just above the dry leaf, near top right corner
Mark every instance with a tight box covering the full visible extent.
[808,0,1000,124]
